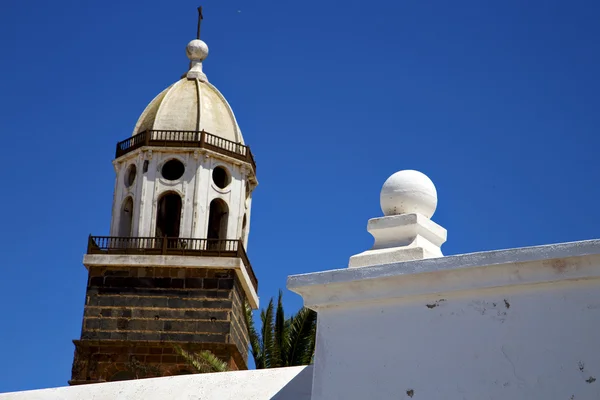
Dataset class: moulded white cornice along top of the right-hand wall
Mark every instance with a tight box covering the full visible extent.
[287,239,600,309]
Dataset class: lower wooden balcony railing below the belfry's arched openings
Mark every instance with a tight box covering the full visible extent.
[87,235,258,291]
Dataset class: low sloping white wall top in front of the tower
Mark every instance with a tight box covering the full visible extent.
[0,366,313,400]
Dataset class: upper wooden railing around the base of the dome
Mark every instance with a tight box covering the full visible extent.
[115,130,256,173]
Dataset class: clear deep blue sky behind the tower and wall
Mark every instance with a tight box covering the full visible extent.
[0,0,600,392]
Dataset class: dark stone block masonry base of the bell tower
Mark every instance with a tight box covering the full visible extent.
[73,267,249,380]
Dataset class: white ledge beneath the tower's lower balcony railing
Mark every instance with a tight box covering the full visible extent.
[83,254,259,310]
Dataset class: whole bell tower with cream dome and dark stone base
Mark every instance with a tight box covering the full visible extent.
[69,9,258,385]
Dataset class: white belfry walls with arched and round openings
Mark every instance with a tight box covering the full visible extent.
[110,149,252,242]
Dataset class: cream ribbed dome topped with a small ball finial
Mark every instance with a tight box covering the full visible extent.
[133,39,244,144]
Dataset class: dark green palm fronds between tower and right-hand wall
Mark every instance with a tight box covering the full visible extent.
[246,290,317,369]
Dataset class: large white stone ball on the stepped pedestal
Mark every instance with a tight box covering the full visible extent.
[380,170,437,218]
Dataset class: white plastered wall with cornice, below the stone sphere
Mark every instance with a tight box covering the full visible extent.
[288,240,600,400]
